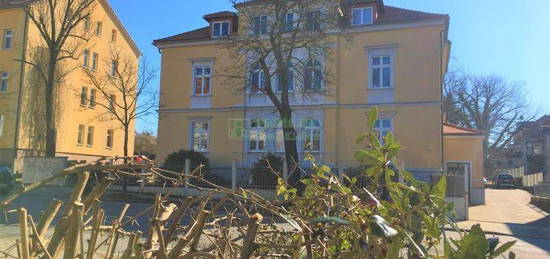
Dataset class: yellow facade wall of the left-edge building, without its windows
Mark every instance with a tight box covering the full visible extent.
[0,0,140,165]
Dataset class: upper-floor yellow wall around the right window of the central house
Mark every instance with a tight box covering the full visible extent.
[337,26,444,104]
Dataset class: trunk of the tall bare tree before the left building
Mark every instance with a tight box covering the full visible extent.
[45,53,57,157]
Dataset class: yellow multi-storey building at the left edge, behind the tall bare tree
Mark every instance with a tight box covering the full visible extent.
[0,0,141,165]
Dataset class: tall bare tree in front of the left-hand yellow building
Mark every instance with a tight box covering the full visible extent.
[21,0,96,156]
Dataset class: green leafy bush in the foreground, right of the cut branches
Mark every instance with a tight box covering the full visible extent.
[270,109,514,259]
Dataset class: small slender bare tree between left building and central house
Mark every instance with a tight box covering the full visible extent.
[83,50,158,160]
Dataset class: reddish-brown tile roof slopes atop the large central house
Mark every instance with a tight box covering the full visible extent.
[153,5,448,44]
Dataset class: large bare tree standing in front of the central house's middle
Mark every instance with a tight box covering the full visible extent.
[223,0,340,188]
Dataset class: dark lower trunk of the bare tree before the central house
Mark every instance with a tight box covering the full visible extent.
[280,108,304,195]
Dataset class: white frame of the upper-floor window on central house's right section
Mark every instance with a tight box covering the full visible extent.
[368,48,395,89]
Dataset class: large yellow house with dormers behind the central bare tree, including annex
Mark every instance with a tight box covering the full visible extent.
[154,0,483,206]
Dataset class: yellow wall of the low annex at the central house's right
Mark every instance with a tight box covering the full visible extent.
[443,136,485,188]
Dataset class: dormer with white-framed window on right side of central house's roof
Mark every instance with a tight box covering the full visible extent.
[344,0,384,26]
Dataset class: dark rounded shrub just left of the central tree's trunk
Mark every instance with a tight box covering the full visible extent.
[250,153,283,188]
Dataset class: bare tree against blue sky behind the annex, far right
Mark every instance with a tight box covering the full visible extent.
[444,73,533,174]
